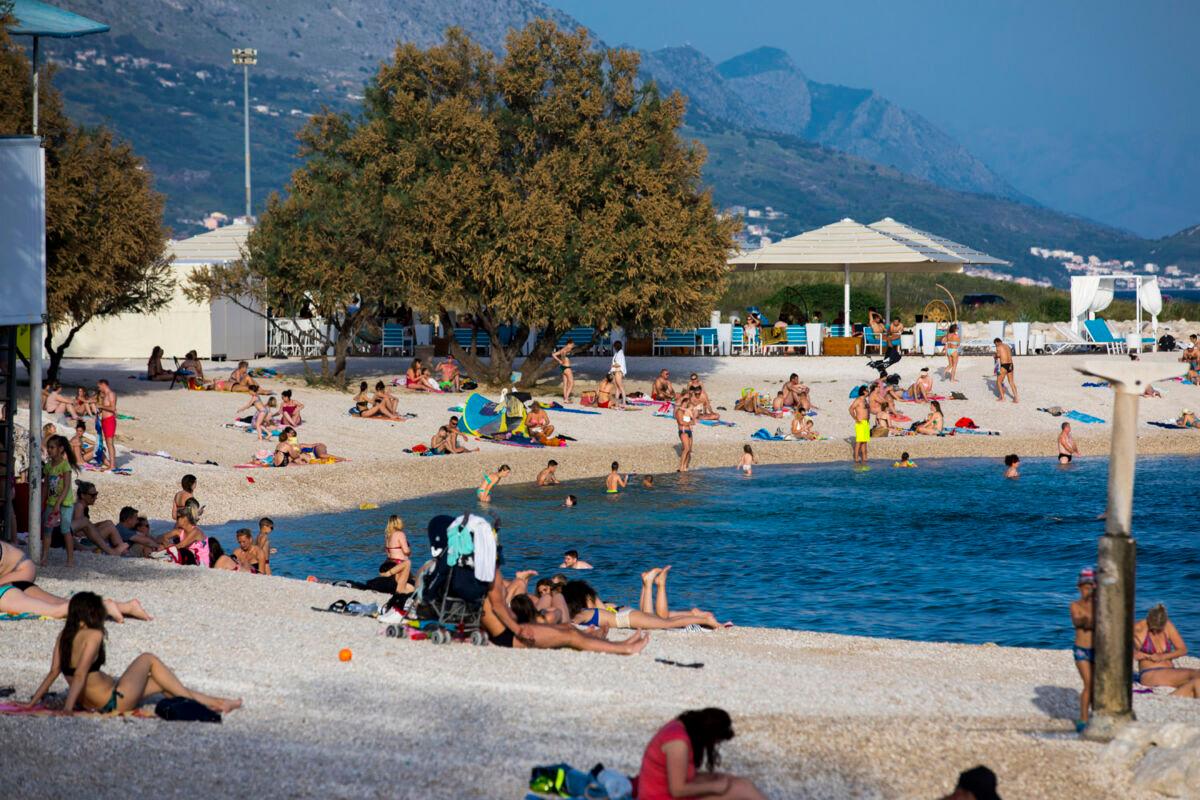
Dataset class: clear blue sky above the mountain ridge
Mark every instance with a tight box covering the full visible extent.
[548,0,1200,235]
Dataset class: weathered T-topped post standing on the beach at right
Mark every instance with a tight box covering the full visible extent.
[1079,361,1184,741]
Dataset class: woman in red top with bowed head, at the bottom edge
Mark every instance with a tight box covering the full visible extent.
[636,709,763,800]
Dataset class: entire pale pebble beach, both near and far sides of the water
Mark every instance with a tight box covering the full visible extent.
[0,354,1200,799]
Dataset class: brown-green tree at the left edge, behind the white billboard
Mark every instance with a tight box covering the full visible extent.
[0,25,174,379]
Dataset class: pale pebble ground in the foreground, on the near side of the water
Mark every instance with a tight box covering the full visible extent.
[0,554,1198,800]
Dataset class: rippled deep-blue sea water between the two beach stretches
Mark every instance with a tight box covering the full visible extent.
[208,457,1200,648]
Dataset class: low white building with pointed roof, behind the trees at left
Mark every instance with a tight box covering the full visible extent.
[67,224,266,368]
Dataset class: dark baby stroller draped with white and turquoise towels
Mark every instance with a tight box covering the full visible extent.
[409,513,498,645]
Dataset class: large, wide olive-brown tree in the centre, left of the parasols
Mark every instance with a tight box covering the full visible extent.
[214,20,736,385]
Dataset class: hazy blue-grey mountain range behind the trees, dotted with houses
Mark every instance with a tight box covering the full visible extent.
[21,0,1200,283]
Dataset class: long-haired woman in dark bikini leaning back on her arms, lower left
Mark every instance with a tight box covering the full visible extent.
[29,591,241,714]
